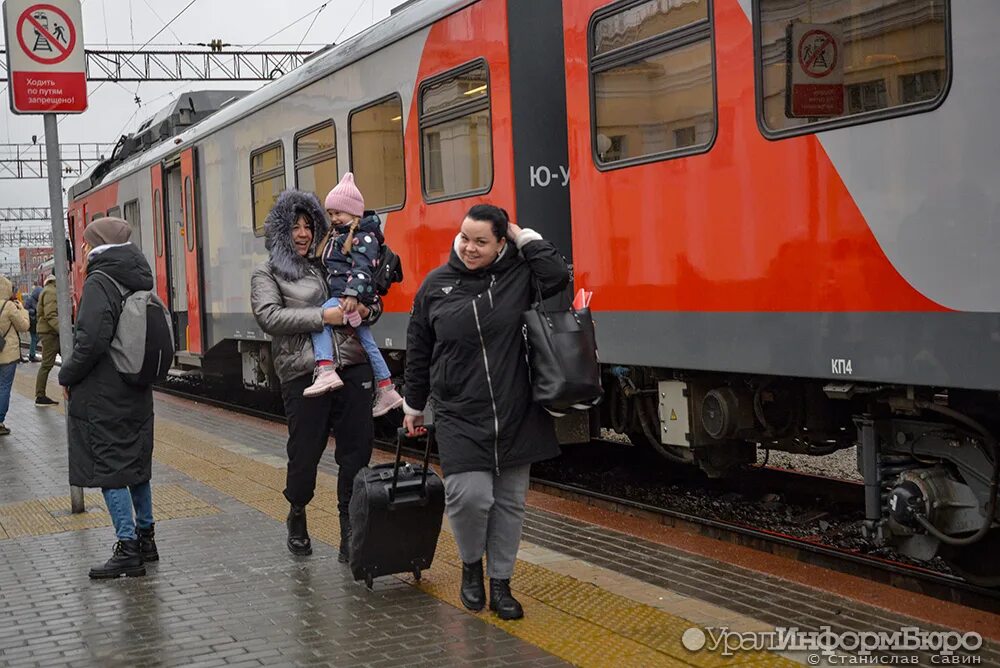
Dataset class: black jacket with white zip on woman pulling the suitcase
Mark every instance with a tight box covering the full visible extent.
[405,230,569,475]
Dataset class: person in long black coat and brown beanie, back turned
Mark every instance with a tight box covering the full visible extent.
[59,218,159,578]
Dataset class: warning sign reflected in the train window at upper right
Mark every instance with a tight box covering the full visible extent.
[787,23,844,118]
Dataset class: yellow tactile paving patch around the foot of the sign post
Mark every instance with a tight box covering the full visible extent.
[0,483,219,540]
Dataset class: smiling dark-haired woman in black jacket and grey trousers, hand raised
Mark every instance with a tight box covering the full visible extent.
[403,204,569,619]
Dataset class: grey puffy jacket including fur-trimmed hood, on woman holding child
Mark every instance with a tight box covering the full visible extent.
[250,190,382,383]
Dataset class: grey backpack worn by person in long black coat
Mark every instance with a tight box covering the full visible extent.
[93,270,174,385]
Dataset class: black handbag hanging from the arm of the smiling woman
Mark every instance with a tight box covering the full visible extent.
[521,289,604,417]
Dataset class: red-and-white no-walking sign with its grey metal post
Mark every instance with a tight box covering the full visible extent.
[3,0,87,513]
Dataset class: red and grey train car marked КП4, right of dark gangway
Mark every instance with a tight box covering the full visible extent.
[563,0,1000,583]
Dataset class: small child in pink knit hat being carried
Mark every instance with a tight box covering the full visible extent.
[302,172,403,417]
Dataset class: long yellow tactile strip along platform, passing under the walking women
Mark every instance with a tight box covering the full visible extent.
[9,378,799,668]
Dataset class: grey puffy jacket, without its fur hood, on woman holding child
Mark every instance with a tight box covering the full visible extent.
[250,262,382,383]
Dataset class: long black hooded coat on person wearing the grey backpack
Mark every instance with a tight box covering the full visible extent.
[59,244,153,487]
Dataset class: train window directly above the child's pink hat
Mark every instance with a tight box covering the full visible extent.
[347,95,406,210]
